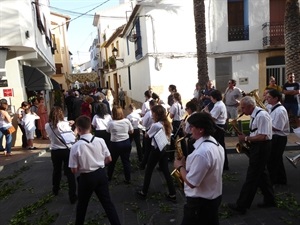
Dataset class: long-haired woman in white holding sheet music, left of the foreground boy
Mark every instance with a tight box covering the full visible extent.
[45,106,77,204]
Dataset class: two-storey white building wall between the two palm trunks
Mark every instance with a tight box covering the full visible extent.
[205,0,270,92]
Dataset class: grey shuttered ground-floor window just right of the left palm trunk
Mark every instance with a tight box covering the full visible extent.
[215,57,232,92]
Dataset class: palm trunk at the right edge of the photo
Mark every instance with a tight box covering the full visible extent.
[284,0,300,81]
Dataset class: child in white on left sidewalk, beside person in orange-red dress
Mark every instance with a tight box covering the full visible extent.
[22,108,40,150]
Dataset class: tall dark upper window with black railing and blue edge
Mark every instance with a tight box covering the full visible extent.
[227,0,249,41]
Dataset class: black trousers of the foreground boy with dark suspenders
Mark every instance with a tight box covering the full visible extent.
[75,168,121,225]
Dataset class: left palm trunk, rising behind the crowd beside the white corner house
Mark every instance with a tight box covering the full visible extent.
[194,0,209,89]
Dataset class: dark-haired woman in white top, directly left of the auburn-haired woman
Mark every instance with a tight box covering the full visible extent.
[92,102,112,149]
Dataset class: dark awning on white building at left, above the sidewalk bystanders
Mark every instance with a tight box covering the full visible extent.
[23,65,53,91]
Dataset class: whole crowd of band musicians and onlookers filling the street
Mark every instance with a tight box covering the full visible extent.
[0,74,300,225]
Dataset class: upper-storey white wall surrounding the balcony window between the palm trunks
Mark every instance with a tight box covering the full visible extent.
[205,0,270,54]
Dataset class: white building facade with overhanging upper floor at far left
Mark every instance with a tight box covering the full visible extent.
[0,0,55,146]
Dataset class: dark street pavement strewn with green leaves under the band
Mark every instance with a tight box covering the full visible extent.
[0,145,300,225]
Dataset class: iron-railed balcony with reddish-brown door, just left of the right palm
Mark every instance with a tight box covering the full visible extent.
[262,22,284,48]
